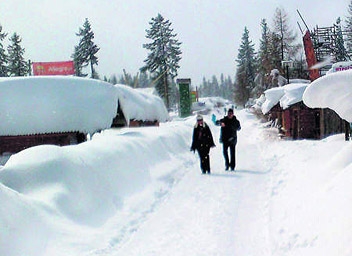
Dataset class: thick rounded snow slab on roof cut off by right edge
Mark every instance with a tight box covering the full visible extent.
[303,70,352,122]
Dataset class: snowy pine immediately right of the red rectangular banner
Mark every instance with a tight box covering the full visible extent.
[72,18,100,78]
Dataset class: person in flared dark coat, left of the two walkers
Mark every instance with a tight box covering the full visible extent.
[191,115,215,174]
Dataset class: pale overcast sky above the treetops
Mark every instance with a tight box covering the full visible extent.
[0,0,351,85]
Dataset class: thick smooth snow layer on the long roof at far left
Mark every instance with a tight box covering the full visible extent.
[0,76,117,136]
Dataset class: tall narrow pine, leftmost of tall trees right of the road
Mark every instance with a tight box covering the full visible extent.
[235,27,256,106]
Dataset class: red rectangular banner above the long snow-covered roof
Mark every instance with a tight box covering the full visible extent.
[33,61,75,76]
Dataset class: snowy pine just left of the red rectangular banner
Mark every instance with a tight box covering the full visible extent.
[7,33,29,76]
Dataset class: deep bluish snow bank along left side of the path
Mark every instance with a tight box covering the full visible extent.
[0,121,193,255]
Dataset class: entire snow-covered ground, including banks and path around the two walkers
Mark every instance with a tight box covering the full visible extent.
[0,105,352,256]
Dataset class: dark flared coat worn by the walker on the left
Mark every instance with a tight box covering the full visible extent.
[191,122,215,152]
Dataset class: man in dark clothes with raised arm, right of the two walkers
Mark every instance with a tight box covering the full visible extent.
[220,108,241,171]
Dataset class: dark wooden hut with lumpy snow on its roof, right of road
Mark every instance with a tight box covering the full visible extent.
[262,83,343,139]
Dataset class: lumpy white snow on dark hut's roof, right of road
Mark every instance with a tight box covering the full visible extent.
[261,83,308,114]
